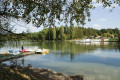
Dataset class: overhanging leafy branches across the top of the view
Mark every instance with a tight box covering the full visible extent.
[0,0,120,27]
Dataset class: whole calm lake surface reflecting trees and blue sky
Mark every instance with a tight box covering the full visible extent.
[0,41,120,80]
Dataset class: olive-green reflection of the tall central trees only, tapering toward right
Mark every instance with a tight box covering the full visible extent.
[37,42,99,61]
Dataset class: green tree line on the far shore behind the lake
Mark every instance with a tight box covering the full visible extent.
[25,24,120,40]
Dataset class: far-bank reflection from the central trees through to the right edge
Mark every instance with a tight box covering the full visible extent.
[37,42,120,61]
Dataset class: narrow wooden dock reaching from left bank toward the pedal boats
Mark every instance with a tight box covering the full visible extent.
[0,52,35,63]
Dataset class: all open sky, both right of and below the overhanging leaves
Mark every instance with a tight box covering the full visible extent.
[5,0,120,33]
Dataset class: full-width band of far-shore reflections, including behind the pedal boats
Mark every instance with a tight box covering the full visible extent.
[0,41,120,61]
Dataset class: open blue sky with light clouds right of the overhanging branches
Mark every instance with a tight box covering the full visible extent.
[85,3,120,29]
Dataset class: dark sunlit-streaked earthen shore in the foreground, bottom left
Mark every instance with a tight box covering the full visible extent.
[0,63,85,80]
